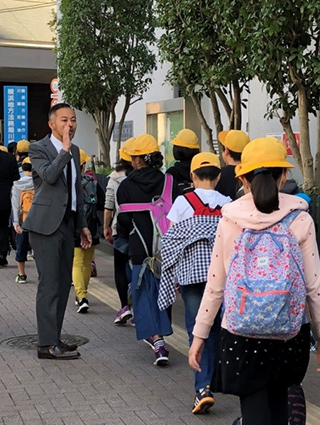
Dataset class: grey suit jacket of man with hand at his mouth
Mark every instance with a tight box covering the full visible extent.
[22,136,87,235]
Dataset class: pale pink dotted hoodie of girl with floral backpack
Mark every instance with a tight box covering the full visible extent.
[193,193,320,340]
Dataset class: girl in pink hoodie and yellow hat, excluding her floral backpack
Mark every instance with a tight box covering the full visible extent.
[189,138,320,425]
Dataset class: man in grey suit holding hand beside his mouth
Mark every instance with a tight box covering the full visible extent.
[23,103,92,360]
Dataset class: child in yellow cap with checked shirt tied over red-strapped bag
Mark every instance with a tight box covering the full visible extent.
[158,152,231,414]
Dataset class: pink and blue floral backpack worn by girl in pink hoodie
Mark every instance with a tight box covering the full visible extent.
[224,210,306,340]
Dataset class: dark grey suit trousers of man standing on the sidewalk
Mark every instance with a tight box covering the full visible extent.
[29,218,74,346]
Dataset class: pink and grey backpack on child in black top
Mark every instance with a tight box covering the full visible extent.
[119,174,173,278]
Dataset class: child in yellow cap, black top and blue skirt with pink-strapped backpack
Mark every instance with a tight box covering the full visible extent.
[117,134,176,366]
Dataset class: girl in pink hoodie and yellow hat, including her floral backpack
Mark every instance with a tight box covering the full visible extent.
[189,138,320,425]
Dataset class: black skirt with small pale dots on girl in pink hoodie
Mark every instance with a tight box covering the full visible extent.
[211,324,310,396]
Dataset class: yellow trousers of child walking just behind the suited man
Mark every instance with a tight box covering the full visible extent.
[72,245,95,300]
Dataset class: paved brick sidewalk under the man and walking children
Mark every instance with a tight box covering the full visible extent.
[0,245,320,425]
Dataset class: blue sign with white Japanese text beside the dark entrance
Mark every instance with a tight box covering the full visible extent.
[3,86,28,146]
